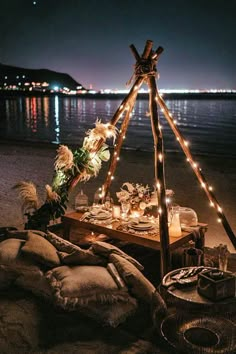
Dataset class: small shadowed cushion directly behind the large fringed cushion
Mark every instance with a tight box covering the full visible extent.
[58,248,106,265]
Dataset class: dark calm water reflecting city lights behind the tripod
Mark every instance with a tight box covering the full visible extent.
[0,96,236,157]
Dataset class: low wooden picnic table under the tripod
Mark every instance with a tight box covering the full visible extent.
[62,212,207,251]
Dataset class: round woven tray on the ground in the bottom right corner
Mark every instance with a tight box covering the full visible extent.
[161,314,236,354]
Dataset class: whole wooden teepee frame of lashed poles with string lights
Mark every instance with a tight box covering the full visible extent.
[101,40,236,276]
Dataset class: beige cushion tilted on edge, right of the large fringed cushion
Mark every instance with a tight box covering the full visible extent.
[109,254,155,303]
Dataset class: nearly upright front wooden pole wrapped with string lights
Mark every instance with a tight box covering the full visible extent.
[148,75,170,277]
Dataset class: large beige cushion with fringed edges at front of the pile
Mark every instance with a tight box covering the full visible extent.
[46,266,130,310]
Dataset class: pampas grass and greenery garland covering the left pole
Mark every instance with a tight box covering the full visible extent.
[13,120,117,230]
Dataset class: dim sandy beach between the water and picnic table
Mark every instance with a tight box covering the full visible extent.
[0,142,236,253]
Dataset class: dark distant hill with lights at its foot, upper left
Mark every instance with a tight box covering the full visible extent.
[0,63,85,90]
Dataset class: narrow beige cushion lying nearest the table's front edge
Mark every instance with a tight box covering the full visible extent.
[91,241,143,270]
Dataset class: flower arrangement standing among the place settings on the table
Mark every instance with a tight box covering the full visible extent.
[116,182,151,210]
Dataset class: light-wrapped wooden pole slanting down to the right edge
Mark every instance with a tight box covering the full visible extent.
[156,93,236,248]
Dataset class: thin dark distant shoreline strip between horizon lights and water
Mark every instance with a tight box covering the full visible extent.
[0,90,236,100]
